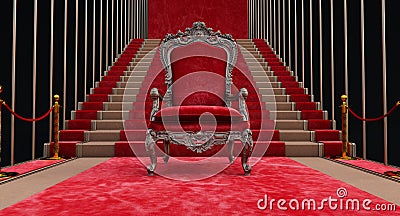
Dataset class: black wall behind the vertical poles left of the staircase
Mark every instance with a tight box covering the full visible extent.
[0,0,125,166]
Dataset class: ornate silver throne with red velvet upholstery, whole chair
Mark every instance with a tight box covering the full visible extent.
[145,22,253,175]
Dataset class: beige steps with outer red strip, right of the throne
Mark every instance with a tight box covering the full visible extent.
[237,39,346,156]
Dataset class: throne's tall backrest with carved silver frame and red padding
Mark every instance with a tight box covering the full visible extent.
[160,22,238,107]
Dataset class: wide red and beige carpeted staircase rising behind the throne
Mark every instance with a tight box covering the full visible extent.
[44,39,348,157]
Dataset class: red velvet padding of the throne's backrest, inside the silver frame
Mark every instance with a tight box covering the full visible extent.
[171,42,227,106]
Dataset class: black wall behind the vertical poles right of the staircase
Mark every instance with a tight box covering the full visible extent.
[286,0,400,166]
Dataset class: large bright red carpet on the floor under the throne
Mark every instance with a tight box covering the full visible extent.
[0,157,400,215]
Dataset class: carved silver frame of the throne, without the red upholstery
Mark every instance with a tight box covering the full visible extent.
[145,22,253,175]
